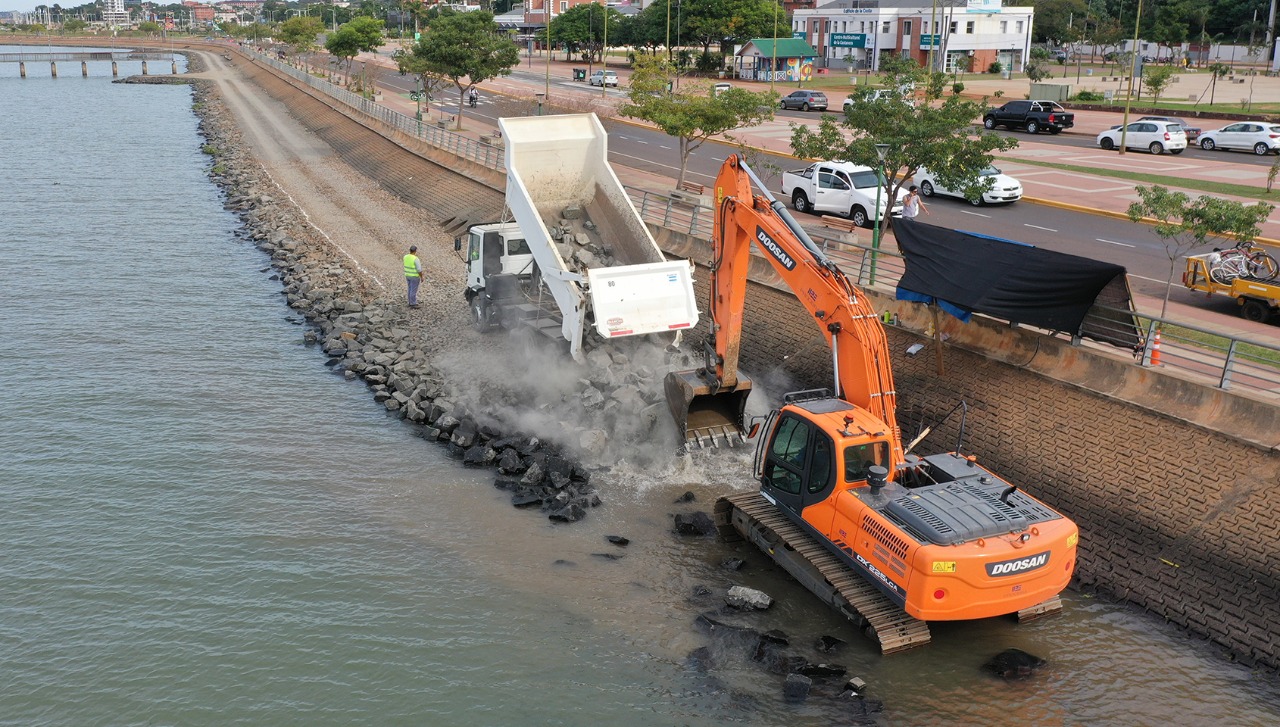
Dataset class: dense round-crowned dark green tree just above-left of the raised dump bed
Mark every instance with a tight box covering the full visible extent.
[413,10,520,129]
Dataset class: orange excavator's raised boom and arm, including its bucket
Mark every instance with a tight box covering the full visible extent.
[666,155,902,463]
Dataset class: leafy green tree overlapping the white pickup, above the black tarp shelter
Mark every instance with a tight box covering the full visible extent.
[791,59,1018,218]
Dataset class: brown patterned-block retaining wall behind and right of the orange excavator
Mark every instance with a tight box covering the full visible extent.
[695,268,1280,669]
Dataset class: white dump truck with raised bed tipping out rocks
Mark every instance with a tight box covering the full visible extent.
[457,114,698,360]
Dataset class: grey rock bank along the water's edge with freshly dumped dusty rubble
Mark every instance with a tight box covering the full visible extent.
[196,83,690,522]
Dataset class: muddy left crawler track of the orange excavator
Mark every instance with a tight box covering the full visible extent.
[716,491,931,654]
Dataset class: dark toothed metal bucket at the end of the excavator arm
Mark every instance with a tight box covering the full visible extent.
[663,370,751,449]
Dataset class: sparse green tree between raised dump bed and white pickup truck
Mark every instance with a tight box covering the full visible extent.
[618,56,778,184]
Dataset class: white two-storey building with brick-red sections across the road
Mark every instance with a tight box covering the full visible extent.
[791,0,1036,73]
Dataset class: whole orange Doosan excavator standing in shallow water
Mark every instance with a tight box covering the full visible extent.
[666,156,1079,653]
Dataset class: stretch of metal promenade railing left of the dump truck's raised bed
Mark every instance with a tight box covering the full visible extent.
[242,49,507,174]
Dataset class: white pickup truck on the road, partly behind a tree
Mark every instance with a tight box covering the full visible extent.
[782,161,902,227]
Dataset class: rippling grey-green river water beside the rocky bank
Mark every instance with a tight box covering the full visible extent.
[0,49,1280,726]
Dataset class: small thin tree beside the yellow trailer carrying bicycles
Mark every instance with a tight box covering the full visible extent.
[1129,184,1275,317]
